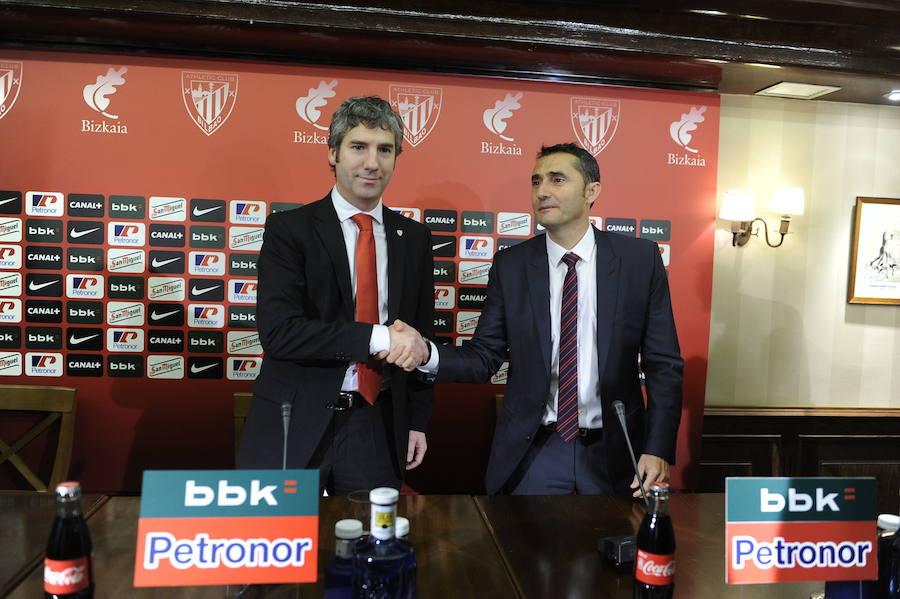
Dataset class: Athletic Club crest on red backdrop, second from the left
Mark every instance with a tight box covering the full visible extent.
[181,71,238,135]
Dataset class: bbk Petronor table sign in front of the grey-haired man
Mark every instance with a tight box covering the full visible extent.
[134,470,319,587]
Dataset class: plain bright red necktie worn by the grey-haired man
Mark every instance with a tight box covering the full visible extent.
[351,214,381,404]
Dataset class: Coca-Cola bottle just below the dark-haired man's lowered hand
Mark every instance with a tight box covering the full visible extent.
[634,483,675,599]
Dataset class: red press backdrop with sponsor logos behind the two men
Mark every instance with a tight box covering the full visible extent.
[0,52,719,493]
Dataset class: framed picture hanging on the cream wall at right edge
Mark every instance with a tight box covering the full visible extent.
[847,197,900,305]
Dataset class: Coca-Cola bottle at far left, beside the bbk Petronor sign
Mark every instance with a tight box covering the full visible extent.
[44,482,94,599]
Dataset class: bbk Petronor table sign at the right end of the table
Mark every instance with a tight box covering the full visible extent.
[725,478,878,584]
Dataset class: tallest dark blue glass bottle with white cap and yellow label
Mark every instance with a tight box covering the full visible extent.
[353,487,411,599]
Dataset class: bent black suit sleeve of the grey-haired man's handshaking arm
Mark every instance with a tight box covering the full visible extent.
[256,214,372,362]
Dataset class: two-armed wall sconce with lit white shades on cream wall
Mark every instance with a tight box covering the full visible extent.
[719,187,803,247]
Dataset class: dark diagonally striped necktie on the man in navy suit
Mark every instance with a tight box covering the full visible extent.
[556,252,579,441]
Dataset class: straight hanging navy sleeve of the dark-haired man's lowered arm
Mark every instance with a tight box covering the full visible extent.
[641,244,684,464]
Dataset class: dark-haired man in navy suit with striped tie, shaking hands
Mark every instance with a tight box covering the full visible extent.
[412,143,684,496]
